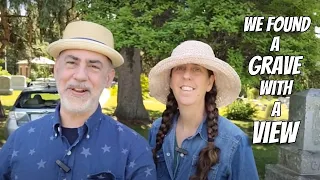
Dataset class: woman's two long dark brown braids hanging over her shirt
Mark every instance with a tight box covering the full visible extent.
[153,70,220,180]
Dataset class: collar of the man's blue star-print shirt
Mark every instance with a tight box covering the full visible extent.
[51,103,103,137]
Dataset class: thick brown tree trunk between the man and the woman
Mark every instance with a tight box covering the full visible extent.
[114,48,149,122]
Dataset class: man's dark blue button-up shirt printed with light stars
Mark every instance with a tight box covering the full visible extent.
[0,106,156,180]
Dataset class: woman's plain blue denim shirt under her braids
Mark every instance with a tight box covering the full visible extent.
[149,115,259,180]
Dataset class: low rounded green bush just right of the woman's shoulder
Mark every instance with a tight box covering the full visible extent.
[226,100,258,121]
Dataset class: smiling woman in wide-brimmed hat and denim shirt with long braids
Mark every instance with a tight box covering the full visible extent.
[149,41,259,180]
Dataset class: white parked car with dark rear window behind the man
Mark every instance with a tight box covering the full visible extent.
[5,82,60,138]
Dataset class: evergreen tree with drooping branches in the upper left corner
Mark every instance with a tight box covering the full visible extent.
[0,0,78,74]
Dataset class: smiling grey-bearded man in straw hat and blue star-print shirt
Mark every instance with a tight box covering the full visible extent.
[0,21,156,180]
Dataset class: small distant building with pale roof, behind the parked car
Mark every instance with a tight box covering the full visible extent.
[17,57,55,77]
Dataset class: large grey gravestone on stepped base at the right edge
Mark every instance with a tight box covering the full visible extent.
[265,89,320,180]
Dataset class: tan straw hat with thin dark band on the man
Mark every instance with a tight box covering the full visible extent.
[47,21,124,67]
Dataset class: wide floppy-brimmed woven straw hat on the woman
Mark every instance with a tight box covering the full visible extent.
[149,40,241,107]
